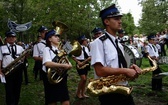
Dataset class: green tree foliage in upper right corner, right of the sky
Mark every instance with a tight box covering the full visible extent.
[140,0,168,34]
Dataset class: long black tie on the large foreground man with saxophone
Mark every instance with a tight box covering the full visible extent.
[115,39,127,68]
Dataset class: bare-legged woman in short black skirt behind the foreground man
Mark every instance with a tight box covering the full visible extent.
[72,35,91,99]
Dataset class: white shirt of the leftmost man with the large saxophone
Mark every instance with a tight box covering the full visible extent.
[0,43,24,68]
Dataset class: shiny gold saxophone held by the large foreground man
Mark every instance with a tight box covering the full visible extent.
[87,56,157,96]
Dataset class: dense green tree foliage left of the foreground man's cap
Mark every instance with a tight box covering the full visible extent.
[0,0,137,42]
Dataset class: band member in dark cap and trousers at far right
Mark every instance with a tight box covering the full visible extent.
[147,34,162,91]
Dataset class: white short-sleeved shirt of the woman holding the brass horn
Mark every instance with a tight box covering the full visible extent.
[42,46,59,72]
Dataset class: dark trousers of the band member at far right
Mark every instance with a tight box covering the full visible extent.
[150,61,162,90]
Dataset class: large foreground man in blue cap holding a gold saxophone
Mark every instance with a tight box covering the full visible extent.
[90,4,141,105]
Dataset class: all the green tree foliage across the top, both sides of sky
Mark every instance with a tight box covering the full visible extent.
[0,0,168,42]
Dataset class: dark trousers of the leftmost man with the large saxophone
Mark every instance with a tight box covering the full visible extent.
[5,70,23,105]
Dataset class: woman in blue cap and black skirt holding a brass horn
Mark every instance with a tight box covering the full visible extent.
[42,30,72,105]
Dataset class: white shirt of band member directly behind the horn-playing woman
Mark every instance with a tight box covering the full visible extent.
[33,40,46,57]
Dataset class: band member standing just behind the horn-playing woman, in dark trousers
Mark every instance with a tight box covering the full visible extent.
[33,26,48,80]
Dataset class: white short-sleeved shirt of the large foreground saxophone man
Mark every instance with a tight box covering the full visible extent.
[90,33,128,85]
